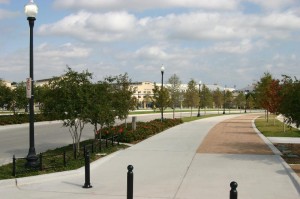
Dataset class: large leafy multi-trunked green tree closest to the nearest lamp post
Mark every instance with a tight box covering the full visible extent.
[42,67,92,152]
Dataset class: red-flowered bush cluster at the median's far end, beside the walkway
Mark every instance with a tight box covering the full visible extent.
[98,119,183,143]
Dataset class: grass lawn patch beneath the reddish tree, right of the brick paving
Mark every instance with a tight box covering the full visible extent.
[255,115,300,137]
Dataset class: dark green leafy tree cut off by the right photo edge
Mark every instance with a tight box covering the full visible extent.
[279,76,300,128]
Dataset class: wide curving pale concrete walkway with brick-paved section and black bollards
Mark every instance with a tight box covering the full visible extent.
[0,115,300,199]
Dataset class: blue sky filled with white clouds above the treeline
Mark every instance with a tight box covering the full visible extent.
[0,0,300,88]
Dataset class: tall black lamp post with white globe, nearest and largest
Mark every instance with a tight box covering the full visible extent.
[24,0,38,167]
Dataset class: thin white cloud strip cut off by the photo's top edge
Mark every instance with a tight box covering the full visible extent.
[54,0,239,11]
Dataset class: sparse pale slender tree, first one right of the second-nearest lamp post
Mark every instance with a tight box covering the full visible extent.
[167,74,181,119]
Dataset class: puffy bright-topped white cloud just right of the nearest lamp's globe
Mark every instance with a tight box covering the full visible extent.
[39,11,135,42]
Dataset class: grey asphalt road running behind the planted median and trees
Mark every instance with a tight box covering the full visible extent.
[0,111,250,165]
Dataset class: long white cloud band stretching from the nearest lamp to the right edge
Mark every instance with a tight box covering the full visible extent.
[39,11,300,42]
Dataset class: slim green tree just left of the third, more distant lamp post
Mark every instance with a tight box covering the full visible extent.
[183,79,199,117]
